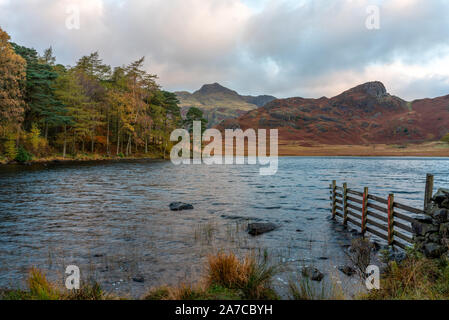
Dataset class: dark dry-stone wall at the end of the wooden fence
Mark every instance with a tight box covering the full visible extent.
[412,189,449,258]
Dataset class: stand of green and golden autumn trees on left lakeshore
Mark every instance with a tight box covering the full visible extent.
[0,25,182,159]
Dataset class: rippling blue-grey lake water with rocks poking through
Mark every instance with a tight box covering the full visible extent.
[0,157,449,297]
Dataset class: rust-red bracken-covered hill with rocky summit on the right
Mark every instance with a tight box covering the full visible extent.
[217,81,449,146]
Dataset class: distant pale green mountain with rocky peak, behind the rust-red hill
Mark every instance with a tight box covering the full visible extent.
[175,83,276,127]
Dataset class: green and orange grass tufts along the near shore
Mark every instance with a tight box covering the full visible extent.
[7,250,449,300]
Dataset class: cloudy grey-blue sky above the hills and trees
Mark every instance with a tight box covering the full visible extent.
[0,0,449,100]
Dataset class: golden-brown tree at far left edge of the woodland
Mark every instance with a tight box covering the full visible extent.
[0,28,26,136]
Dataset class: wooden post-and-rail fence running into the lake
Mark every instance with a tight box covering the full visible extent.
[329,174,433,249]
